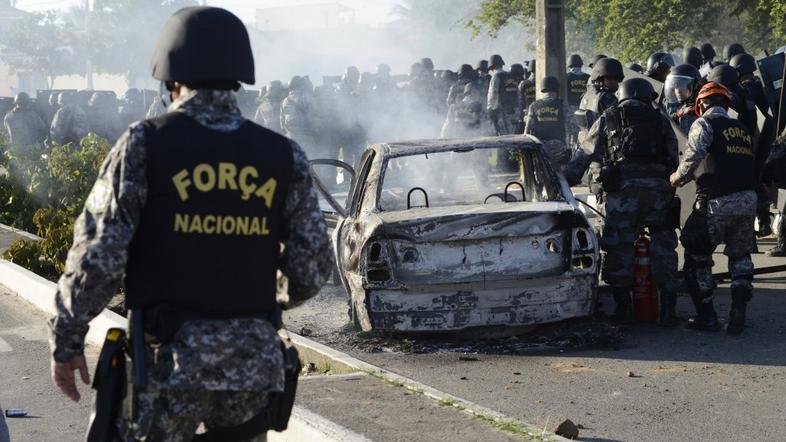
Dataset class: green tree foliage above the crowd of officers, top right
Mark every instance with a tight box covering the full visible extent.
[467,0,786,61]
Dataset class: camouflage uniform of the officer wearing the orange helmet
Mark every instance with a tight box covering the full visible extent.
[677,107,757,320]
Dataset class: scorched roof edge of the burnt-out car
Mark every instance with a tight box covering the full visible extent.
[372,135,540,157]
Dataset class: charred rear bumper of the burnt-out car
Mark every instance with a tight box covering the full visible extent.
[367,273,597,332]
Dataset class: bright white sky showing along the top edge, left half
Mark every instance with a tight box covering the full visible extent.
[16,0,398,25]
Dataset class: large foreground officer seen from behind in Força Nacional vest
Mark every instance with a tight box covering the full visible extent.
[50,7,332,441]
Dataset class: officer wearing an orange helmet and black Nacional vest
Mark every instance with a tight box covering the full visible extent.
[671,82,756,335]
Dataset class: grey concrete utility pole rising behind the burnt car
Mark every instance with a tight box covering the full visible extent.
[535,0,568,103]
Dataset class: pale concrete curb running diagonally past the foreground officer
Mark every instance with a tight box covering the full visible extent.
[0,254,568,442]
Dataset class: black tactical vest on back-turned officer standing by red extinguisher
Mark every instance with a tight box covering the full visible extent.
[604,106,666,165]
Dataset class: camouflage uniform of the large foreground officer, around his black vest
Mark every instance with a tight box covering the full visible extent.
[50,90,332,441]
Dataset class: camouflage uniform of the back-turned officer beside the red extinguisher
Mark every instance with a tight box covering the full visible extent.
[565,100,679,302]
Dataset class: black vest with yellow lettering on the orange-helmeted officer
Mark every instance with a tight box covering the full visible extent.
[696,114,756,198]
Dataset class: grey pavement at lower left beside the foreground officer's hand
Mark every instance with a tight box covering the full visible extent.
[0,287,98,442]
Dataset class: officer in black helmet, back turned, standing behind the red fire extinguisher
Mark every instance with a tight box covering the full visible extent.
[565,78,679,325]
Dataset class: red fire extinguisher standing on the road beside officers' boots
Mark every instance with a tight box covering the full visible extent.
[633,228,658,322]
